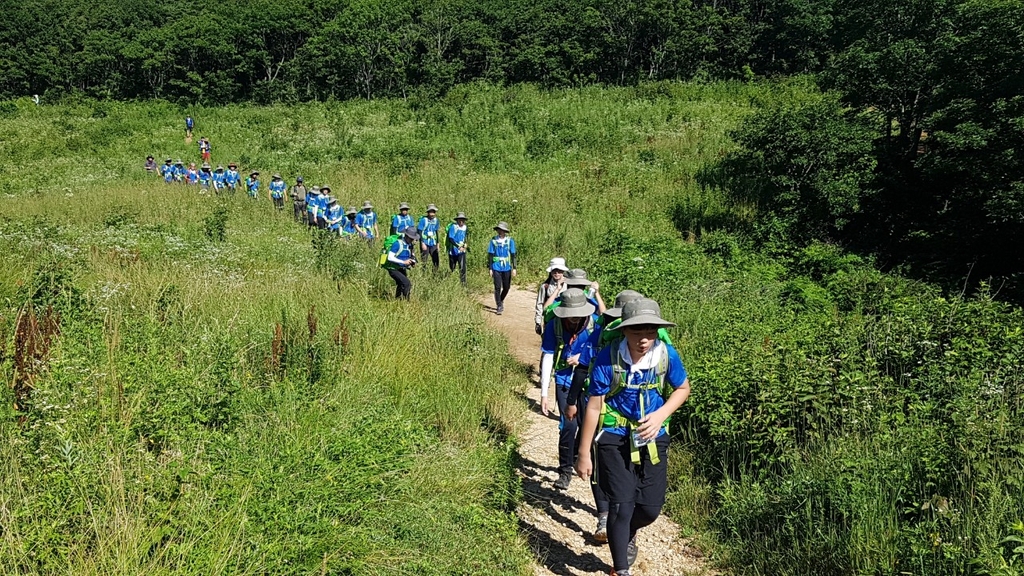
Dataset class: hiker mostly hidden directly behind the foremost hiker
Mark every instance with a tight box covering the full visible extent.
[565,290,643,543]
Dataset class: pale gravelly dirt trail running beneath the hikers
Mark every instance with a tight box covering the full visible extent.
[480,287,711,576]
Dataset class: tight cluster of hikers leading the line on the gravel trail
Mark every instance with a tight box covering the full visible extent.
[535,258,690,576]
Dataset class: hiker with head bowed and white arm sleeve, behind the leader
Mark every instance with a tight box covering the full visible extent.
[541,288,596,490]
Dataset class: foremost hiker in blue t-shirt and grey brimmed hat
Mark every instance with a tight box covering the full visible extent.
[575,298,690,576]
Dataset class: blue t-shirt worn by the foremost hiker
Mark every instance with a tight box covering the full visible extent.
[590,340,686,436]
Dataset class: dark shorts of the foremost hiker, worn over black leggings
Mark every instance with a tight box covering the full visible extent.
[595,433,669,506]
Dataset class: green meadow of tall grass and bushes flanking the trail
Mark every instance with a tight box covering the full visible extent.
[0,80,1024,575]
